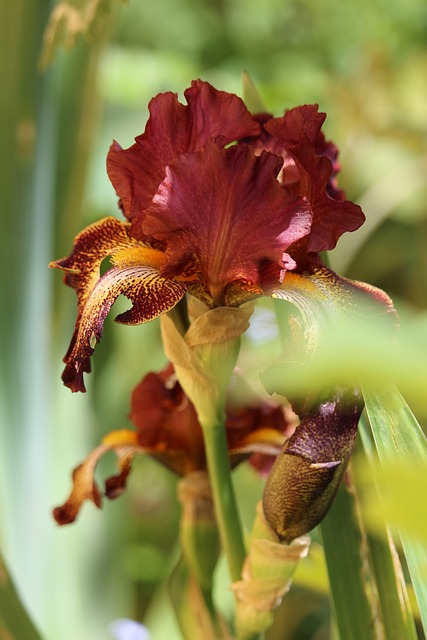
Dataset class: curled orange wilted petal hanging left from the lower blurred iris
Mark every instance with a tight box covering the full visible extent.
[53,430,144,524]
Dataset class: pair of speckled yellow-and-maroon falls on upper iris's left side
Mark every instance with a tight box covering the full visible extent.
[50,218,187,391]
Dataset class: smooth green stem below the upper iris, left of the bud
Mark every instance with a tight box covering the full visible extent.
[202,423,246,581]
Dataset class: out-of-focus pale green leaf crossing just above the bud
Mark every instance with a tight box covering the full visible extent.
[264,314,427,418]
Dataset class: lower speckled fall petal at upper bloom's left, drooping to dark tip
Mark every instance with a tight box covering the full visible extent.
[62,265,187,391]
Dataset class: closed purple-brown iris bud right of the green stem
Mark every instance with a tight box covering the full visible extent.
[263,389,363,542]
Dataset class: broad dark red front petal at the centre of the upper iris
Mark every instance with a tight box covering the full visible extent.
[143,142,311,304]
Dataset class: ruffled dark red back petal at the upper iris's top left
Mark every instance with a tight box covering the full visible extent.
[107,80,260,239]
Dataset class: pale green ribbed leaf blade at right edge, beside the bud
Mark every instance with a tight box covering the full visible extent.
[364,384,427,631]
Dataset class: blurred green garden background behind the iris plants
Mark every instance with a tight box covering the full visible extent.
[0,0,427,640]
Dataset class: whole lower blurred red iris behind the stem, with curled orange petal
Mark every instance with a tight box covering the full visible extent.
[54,365,296,524]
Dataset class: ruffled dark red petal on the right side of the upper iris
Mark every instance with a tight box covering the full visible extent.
[264,105,365,255]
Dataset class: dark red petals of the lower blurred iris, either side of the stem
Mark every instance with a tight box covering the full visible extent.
[130,365,291,476]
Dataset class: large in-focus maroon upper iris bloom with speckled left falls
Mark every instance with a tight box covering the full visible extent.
[52,81,372,391]
